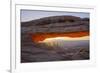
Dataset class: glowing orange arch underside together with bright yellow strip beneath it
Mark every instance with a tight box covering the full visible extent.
[32,32,89,42]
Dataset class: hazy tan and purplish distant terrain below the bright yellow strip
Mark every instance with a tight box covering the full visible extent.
[41,40,89,49]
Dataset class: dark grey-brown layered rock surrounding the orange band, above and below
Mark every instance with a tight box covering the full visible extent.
[21,16,89,63]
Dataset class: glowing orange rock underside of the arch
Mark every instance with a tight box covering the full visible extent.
[32,32,89,42]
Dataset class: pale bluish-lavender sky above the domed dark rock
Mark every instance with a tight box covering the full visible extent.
[21,10,89,22]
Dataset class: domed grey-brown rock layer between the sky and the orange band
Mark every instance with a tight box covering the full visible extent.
[21,16,89,33]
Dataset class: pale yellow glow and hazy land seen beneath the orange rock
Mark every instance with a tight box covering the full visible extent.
[38,36,89,47]
